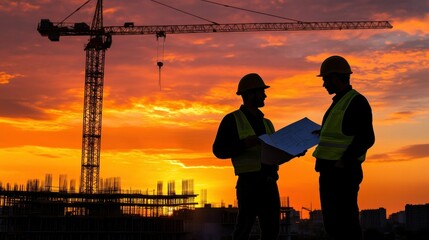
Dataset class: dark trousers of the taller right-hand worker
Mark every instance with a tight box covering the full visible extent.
[319,166,363,240]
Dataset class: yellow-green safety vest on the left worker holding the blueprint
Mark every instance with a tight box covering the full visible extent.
[231,110,274,175]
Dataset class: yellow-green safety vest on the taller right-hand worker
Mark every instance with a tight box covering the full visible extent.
[313,89,365,161]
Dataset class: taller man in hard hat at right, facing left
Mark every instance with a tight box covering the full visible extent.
[313,56,375,240]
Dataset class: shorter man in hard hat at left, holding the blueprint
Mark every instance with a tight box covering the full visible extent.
[213,73,280,240]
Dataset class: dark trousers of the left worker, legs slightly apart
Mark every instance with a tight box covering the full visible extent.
[233,176,280,240]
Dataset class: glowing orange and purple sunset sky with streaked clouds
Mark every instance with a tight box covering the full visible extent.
[0,0,429,217]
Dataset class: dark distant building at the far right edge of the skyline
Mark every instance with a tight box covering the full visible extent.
[405,203,429,231]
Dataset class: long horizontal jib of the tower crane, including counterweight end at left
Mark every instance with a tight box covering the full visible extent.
[37,19,392,41]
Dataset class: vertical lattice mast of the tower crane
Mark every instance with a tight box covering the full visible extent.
[79,1,110,193]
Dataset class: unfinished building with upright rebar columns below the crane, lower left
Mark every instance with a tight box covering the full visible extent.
[0,180,197,240]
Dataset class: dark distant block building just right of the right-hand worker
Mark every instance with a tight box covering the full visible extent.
[360,208,387,231]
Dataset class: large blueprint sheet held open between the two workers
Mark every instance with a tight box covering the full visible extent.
[259,117,320,156]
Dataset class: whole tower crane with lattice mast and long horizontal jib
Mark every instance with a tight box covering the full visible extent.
[37,0,392,194]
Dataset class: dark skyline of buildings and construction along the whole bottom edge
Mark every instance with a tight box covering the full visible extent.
[0,185,429,240]
